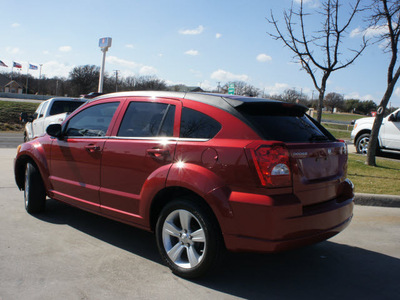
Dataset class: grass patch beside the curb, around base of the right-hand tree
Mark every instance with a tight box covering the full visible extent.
[347,154,400,196]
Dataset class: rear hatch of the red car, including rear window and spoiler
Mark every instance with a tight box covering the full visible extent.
[236,101,347,205]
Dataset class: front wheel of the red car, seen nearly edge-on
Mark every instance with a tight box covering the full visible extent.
[24,162,46,214]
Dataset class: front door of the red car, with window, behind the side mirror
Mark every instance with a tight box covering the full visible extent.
[50,101,120,211]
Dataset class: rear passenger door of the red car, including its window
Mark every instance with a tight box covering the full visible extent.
[100,98,180,222]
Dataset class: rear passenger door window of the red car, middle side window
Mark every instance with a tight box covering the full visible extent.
[117,101,175,137]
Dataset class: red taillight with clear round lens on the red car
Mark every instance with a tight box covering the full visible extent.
[247,143,292,188]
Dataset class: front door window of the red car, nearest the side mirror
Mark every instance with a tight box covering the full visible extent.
[65,102,119,137]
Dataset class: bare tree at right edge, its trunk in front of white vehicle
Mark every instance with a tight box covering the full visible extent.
[367,0,400,166]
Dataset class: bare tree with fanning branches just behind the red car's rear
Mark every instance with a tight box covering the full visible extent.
[268,0,367,122]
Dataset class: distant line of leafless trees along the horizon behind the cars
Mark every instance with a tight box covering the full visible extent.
[3,65,394,115]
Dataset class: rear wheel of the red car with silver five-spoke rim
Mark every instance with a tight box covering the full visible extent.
[156,198,224,278]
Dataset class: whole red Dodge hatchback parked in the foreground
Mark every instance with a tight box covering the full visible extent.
[15,92,354,278]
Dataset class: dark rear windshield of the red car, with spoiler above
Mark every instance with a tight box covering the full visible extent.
[237,103,335,143]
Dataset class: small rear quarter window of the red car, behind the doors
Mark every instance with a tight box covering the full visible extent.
[180,107,221,139]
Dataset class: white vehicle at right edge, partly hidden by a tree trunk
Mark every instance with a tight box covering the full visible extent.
[351,109,400,154]
